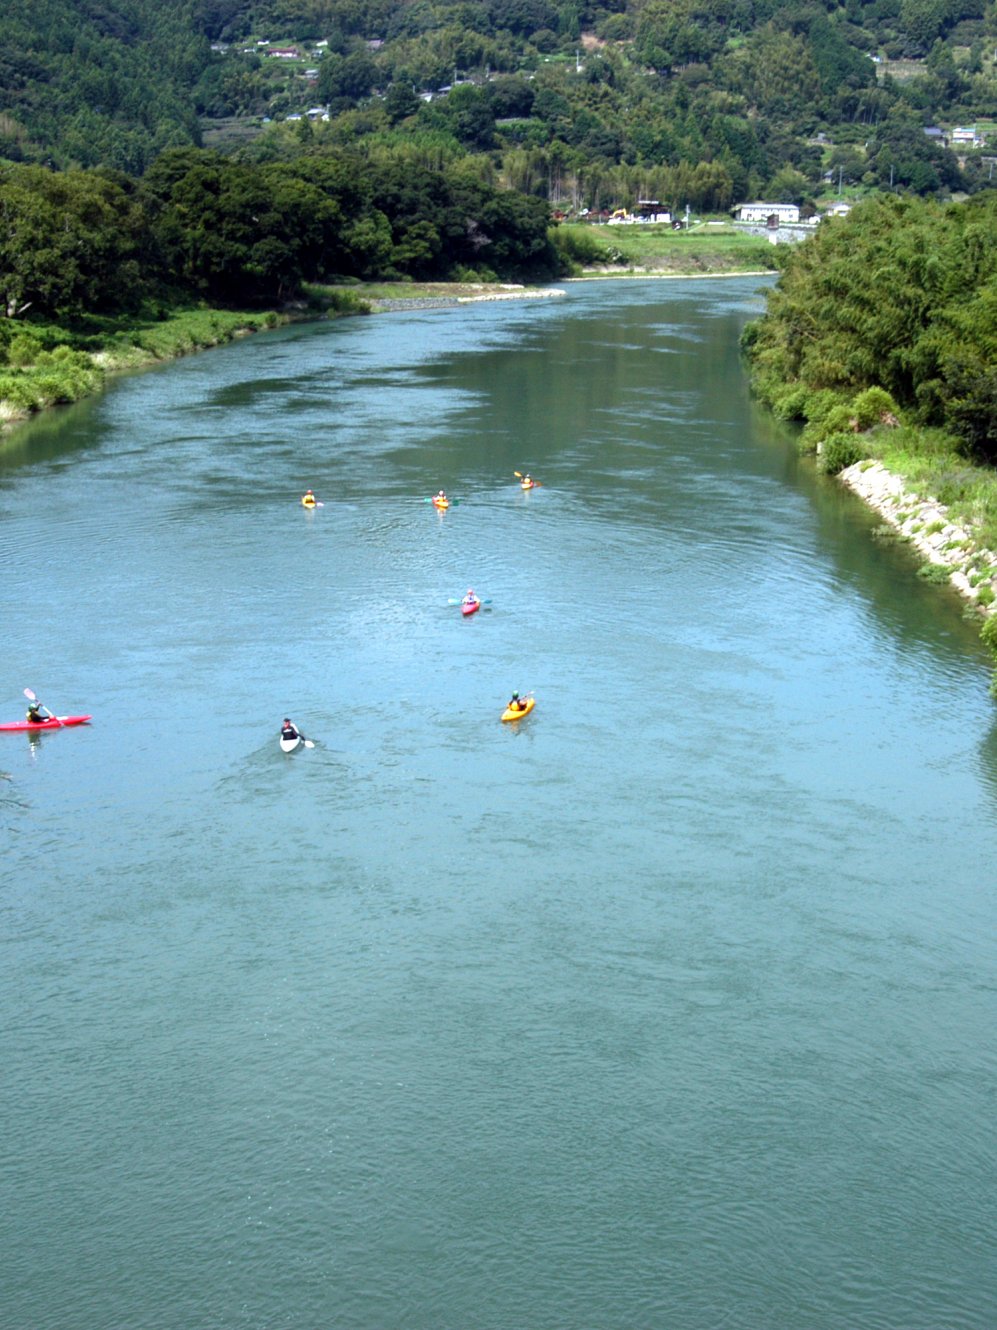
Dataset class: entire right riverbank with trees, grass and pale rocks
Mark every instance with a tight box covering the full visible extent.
[742,192,997,697]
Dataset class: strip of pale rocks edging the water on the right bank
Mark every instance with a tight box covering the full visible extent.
[840,462,997,614]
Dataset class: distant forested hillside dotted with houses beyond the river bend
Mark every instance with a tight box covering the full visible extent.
[0,0,997,210]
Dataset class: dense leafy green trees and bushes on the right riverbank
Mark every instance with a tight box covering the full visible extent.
[743,190,997,467]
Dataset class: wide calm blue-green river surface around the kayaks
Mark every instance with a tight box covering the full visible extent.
[0,279,997,1330]
